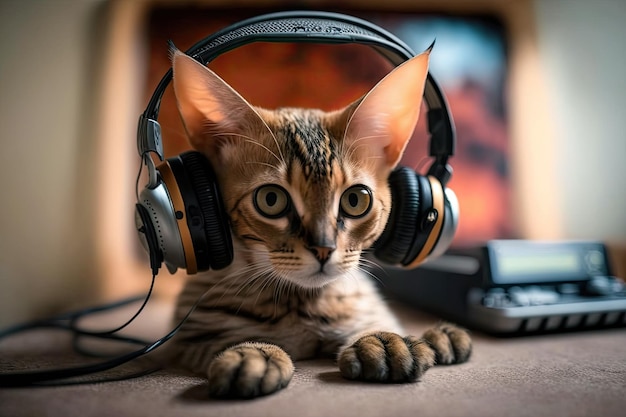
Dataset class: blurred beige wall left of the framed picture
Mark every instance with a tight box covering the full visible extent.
[0,0,106,324]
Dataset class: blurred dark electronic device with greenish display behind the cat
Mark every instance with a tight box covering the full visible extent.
[381,240,626,335]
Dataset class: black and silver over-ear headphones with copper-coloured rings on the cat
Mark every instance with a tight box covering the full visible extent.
[135,11,459,275]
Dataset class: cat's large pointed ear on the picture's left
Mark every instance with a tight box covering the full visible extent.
[171,48,266,155]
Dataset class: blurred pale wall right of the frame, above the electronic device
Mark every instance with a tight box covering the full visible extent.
[529,0,626,242]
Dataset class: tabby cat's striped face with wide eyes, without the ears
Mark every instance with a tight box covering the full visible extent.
[205,109,390,287]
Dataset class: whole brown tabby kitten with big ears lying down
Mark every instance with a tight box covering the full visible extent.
[163,44,472,398]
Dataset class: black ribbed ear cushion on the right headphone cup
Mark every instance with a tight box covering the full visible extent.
[374,167,420,265]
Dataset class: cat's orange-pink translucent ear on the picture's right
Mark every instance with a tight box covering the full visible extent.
[344,46,432,170]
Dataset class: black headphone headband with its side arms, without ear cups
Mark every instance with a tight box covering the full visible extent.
[137,11,455,186]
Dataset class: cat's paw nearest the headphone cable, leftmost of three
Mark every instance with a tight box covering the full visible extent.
[209,342,294,398]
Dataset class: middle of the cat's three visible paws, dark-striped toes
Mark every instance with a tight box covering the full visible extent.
[339,332,435,382]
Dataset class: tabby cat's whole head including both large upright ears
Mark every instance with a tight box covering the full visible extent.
[173,47,428,288]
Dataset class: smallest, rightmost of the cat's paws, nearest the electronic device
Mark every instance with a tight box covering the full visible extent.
[422,323,472,365]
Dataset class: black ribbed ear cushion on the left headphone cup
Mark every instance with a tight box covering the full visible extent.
[179,151,233,269]
